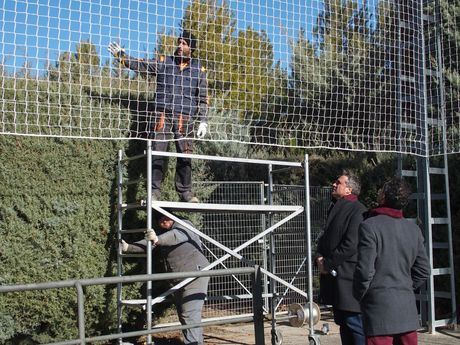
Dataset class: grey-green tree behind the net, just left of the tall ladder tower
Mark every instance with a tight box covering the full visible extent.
[289,0,397,149]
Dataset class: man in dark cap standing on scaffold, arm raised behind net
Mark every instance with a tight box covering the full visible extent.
[108,30,208,202]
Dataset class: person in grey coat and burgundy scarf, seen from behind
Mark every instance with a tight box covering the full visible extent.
[353,178,430,345]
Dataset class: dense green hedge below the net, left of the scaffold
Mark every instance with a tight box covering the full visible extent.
[0,136,117,343]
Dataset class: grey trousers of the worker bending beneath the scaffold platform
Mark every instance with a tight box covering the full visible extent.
[174,277,209,345]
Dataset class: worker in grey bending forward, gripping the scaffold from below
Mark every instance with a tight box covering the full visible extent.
[121,215,209,345]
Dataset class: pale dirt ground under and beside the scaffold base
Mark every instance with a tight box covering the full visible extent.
[146,314,460,345]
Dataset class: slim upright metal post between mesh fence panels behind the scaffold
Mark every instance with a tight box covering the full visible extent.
[268,164,277,345]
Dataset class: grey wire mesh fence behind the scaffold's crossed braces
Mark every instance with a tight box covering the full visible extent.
[196,182,330,318]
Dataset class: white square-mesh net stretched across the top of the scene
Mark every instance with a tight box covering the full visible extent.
[0,0,460,155]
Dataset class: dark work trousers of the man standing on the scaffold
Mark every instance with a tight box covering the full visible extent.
[150,112,193,197]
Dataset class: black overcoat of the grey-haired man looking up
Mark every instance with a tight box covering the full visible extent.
[317,199,366,313]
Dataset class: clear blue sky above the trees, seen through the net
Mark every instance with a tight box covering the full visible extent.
[0,0,322,73]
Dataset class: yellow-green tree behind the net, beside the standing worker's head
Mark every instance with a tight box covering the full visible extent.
[181,0,275,118]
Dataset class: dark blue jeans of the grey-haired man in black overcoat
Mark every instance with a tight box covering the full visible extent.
[334,308,366,345]
